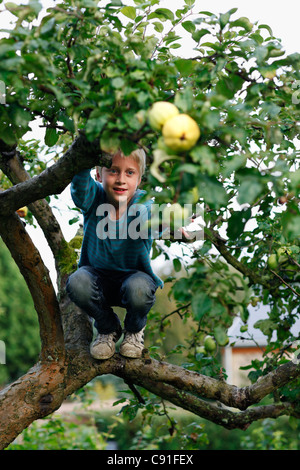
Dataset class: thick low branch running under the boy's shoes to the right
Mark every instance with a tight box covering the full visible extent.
[0,344,300,448]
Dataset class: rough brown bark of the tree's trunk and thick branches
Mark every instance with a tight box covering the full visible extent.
[0,136,300,449]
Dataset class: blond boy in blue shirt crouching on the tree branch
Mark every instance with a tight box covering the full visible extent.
[67,149,163,359]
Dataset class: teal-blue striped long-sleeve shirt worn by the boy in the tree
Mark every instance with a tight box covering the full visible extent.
[71,170,163,287]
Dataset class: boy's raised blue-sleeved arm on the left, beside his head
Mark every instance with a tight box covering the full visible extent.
[71,170,100,212]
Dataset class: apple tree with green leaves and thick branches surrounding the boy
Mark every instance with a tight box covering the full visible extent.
[0,0,300,448]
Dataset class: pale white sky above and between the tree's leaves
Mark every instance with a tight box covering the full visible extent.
[0,0,300,283]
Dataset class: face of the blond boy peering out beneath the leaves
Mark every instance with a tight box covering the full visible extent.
[97,154,141,207]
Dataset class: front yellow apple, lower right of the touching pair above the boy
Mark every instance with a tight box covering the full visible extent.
[162,114,200,152]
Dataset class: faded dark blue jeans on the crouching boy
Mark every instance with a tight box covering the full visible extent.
[66,266,157,334]
